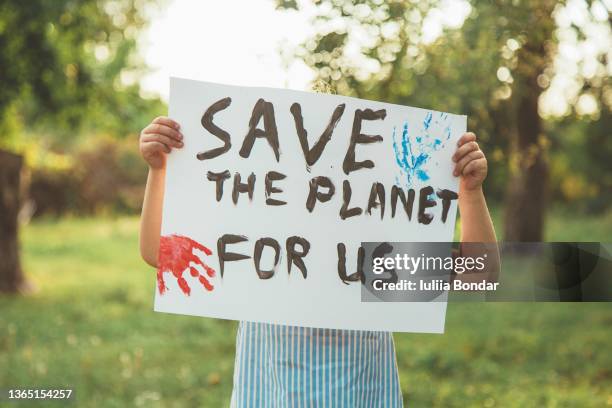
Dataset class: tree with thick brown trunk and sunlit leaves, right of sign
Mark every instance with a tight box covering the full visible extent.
[277,0,610,241]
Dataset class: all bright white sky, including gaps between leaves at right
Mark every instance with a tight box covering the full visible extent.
[139,0,612,115]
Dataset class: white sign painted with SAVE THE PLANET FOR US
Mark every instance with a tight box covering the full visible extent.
[155,78,466,333]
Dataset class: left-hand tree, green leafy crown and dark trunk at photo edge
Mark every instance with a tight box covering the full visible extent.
[0,0,158,292]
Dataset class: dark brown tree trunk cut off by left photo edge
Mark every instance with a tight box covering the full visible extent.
[0,150,26,293]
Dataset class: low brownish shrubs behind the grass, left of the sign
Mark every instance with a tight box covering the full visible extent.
[25,136,147,216]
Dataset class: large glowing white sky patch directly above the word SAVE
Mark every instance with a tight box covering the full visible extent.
[140,0,313,99]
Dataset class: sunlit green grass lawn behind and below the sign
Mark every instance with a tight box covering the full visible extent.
[0,214,612,407]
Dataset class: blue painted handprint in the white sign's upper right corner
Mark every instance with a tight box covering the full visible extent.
[393,112,450,186]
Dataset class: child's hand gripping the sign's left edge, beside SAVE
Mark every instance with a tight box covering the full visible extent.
[140,116,183,170]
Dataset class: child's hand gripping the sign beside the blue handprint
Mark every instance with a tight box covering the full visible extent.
[453,132,487,191]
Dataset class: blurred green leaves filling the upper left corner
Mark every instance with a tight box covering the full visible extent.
[0,0,162,149]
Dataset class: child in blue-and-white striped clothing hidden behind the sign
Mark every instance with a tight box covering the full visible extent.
[140,117,496,407]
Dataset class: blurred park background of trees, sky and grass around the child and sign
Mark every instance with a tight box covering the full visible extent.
[0,0,612,407]
